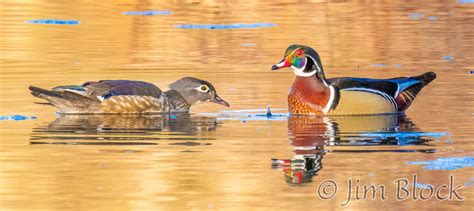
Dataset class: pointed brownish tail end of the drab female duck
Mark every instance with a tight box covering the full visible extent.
[28,86,100,113]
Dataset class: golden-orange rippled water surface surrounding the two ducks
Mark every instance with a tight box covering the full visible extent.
[0,0,474,209]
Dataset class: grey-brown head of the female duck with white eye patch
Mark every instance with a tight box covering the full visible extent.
[170,77,230,107]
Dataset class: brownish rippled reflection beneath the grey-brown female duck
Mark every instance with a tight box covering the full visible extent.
[30,113,219,146]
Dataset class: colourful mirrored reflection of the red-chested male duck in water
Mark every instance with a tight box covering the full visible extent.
[272,115,432,184]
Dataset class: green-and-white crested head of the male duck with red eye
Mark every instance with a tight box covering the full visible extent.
[272,45,323,77]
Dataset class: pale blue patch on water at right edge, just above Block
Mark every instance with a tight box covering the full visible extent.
[407,156,474,170]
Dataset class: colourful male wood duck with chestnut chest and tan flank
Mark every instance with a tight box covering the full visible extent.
[272,45,436,115]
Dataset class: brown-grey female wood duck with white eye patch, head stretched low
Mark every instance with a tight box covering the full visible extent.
[29,77,229,114]
